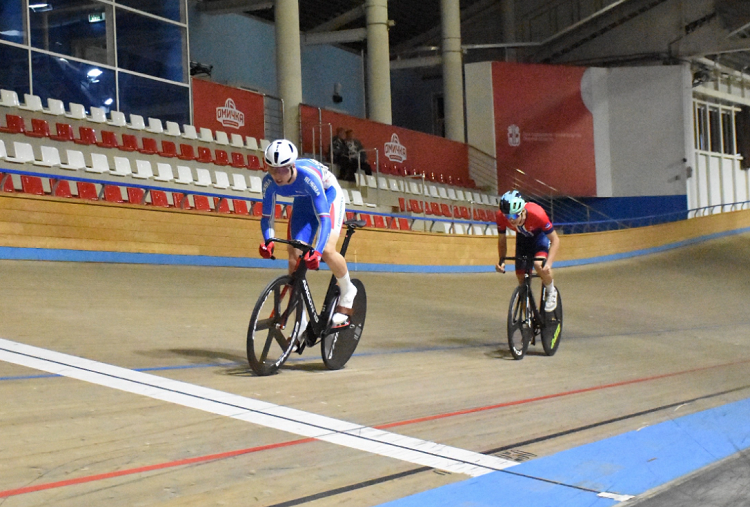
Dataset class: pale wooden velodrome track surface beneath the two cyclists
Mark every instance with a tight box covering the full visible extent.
[0,232,750,507]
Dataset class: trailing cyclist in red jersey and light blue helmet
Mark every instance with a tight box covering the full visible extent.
[495,190,560,312]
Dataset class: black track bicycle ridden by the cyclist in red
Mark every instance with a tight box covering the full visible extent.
[505,257,563,359]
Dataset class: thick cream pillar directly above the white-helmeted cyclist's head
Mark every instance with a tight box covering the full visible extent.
[276,0,302,146]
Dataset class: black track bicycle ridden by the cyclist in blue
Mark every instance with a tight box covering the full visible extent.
[247,220,367,376]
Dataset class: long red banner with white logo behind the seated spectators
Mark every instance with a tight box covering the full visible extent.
[300,105,469,182]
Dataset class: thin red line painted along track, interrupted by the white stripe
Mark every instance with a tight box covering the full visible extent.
[0,359,750,498]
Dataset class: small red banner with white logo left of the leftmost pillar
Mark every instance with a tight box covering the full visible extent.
[193,78,265,143]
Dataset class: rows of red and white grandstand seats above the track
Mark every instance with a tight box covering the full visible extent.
[0,90,497,232]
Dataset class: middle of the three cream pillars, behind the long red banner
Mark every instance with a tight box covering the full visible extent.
[365,0,393,125]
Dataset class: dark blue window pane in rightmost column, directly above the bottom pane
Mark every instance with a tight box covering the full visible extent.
[117,9,187,83]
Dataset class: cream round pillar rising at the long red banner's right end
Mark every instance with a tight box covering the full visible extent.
[440,0,466,143]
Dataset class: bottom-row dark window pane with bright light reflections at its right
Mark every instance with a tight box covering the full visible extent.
[31,52,115,111]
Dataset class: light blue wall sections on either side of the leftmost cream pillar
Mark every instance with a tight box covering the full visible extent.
[188,8,365,117]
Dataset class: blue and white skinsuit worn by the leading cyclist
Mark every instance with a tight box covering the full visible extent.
[260,158,344,252]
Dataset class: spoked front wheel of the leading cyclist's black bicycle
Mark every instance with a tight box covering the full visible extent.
[247,276,304,375]
